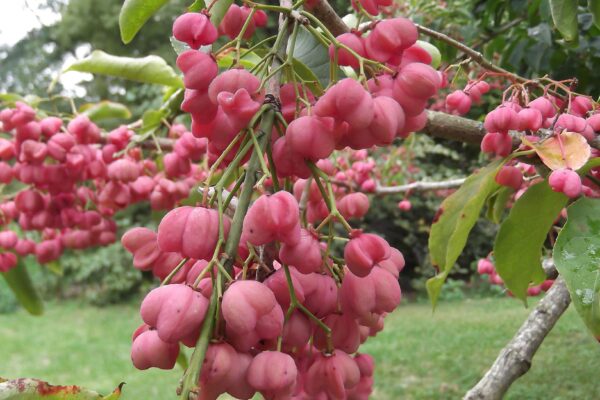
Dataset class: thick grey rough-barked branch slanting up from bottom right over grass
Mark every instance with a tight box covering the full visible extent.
[464,277,571,400]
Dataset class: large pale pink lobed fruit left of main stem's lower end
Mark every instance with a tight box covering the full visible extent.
[140,284,208,343]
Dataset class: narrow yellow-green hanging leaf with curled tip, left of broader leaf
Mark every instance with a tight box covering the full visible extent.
[427,160,505,307]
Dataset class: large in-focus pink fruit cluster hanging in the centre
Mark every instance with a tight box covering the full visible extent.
[122,4,443,399]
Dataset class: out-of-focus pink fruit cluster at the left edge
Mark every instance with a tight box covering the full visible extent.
[0,102,206,271]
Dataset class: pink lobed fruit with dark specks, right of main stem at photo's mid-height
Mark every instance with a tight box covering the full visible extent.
[241,191,300,245]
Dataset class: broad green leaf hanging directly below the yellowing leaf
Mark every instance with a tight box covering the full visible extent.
[494,181,569,304]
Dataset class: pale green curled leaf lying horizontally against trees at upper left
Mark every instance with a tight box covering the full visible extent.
[65,50,183,87]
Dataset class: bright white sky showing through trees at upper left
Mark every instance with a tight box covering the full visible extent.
[0,0,92,97]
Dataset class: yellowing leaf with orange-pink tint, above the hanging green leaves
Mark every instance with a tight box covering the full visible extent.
[523,132,592,170]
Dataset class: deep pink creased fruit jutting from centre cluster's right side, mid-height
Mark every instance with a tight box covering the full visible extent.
[344,231,391,277]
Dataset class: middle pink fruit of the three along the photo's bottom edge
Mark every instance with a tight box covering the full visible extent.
[246,351,298,399]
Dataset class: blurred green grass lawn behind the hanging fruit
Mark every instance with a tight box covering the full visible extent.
[0,298,600,400]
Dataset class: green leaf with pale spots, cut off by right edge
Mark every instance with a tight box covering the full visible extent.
[553,197,600,340]
